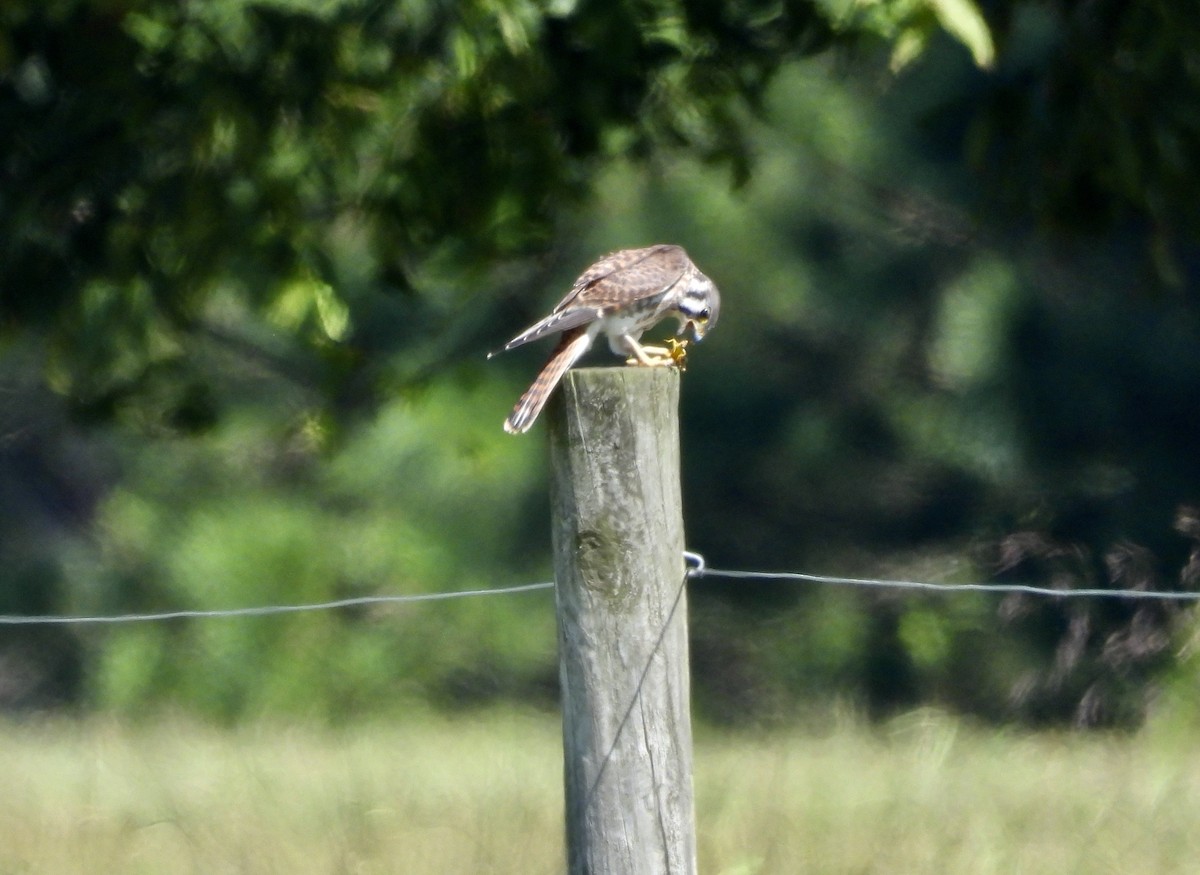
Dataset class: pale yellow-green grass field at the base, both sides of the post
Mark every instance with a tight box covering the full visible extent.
[0,713,1200,875]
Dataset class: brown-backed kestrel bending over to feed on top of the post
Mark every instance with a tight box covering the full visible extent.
[488,244,721,434]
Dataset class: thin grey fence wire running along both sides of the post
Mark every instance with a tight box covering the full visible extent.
[0,552,1200,625]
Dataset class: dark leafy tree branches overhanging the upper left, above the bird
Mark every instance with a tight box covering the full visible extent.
[0,0,859,415]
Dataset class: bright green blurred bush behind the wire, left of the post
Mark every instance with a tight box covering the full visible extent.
[89,389,553,720]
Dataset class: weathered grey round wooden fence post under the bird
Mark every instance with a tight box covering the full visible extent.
[551,367,696,875]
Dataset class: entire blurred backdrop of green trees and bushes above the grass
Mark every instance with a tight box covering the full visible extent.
[0,0,1200,726]
